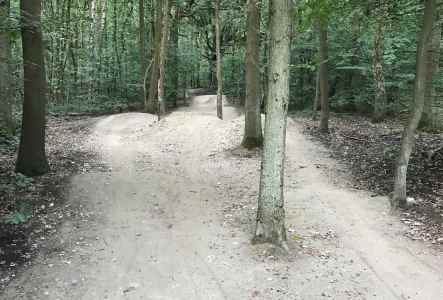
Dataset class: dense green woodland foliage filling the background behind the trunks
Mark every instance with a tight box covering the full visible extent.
[2,0,443,123]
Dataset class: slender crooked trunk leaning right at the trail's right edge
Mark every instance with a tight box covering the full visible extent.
[391,0,436,209]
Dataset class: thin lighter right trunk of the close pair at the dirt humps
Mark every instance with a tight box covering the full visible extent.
[157,0,171,121]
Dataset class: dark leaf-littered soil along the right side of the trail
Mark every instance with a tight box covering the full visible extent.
[297,116,443,245]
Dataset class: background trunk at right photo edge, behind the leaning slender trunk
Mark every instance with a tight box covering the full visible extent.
[420,9,443,130]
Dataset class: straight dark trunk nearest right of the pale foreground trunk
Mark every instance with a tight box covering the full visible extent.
[318,20,329,132]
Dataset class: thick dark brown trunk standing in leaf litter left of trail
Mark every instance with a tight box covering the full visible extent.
[16,0,49,176]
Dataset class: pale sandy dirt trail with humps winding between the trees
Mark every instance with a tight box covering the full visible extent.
[1,96,443,300]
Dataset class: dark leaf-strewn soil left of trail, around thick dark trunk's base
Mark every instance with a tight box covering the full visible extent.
[0,116,101,290]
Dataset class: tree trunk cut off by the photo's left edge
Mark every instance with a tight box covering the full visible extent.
[0,0,15,135]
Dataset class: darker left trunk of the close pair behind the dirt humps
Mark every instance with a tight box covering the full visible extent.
[145,0,164,113]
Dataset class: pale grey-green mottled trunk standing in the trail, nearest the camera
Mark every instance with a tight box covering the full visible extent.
[254,0,291,248]
